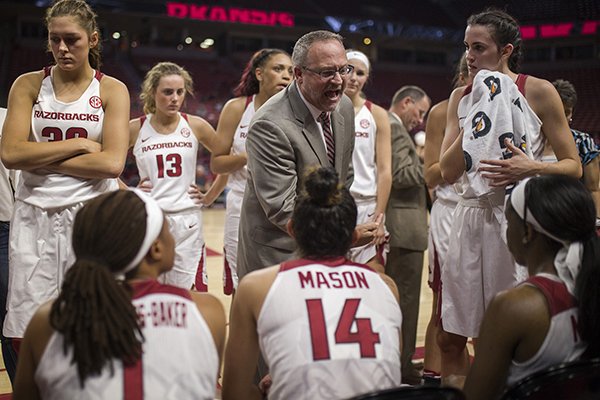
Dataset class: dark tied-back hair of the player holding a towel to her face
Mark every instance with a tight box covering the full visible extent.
[467,8,523,72]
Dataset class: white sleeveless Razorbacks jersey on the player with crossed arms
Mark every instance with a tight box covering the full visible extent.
[16,67,117,209]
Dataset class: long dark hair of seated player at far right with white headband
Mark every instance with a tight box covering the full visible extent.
[525,175,600,357]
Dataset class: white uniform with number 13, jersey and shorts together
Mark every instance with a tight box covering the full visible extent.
[133,113,207,291]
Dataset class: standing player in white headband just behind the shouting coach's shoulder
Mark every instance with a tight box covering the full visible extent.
[344,50,392,272]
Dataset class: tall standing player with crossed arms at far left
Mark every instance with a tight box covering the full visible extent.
[2,0,129,338]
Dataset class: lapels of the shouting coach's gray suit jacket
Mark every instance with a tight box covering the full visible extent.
[288,81,330,165]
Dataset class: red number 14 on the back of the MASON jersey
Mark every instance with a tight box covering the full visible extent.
[306,299,380,361]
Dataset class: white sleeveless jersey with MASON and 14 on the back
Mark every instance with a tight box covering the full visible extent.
[257,258,402,400]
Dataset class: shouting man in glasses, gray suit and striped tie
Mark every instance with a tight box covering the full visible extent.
[238,31,376,278]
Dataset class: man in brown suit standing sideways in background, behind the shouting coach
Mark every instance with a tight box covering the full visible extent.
[385,86,431,385]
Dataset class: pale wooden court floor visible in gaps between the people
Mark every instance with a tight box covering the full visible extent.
[0,208,432,400]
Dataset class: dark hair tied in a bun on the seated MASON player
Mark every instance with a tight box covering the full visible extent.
[292,167,357,258]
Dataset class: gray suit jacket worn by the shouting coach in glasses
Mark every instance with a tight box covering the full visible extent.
[237,82,355,278]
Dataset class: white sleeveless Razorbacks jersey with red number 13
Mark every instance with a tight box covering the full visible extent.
[133,113,198,212]
